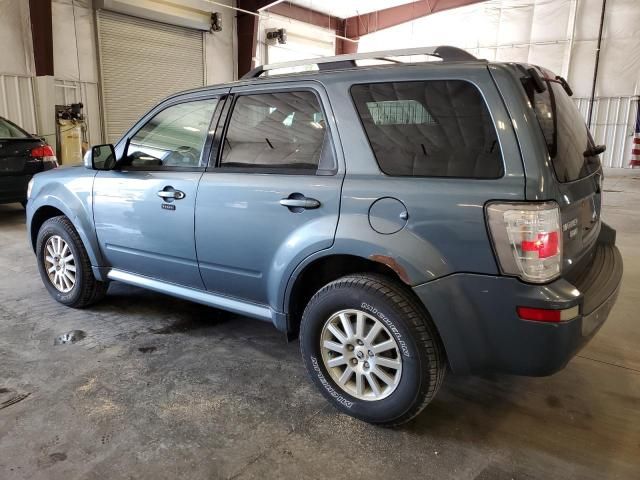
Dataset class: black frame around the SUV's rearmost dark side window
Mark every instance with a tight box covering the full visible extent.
[348,77,507,182]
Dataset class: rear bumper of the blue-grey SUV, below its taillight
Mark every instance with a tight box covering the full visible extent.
[414,225,622,376]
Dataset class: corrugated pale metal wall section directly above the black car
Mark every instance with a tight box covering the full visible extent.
[0,75,37,133]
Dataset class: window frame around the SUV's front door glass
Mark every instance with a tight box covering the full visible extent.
[114,92,226,172]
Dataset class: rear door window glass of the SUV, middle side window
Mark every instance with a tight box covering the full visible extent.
[219,91,336,175]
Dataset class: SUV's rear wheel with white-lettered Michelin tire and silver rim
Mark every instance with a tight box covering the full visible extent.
[300,274,447,427]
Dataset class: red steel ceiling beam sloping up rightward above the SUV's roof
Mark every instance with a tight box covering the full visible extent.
[344,0,485,40]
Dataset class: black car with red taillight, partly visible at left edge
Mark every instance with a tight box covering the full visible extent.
[0,117,58,205]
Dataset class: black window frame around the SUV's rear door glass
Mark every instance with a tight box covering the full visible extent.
[206,85,339,177]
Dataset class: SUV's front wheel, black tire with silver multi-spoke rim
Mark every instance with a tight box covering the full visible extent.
[36,216,109,308]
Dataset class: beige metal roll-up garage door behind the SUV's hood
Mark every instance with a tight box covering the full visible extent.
[97,10,204,143]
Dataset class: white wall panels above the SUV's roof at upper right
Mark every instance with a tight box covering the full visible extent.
[358,0,640,97]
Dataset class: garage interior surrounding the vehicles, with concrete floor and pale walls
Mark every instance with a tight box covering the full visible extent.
[0,0,640,480]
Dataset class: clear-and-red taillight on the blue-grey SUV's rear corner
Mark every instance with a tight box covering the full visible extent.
[486,202,562,283]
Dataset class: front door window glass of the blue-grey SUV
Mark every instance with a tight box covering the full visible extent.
[121,98,218,170]
